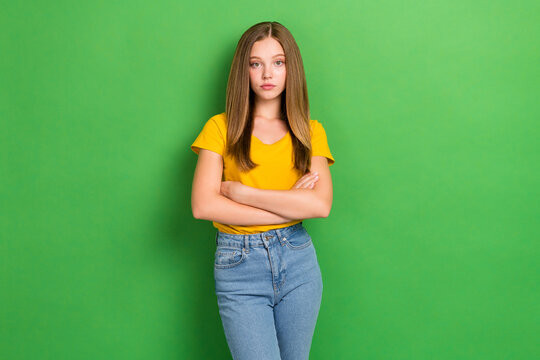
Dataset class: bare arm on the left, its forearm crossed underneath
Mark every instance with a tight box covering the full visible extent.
[191,149,296,225]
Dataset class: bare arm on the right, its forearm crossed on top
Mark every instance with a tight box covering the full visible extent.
[225,156,333,219]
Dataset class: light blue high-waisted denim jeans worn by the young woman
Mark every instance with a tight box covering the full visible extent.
[214,222,323,360]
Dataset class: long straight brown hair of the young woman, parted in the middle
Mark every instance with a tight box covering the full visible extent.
[225,21,311,175]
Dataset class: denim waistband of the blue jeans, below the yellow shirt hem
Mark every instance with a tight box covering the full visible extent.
[216,222,304,248]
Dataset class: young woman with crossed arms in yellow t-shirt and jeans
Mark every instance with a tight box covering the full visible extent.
[191,21,334,360]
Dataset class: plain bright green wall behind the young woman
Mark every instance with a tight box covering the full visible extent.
[0,0,540,360]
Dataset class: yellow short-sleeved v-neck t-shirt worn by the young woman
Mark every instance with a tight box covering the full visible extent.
[191,112,334,234]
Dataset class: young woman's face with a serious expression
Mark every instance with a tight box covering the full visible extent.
[249,37,287,100]
